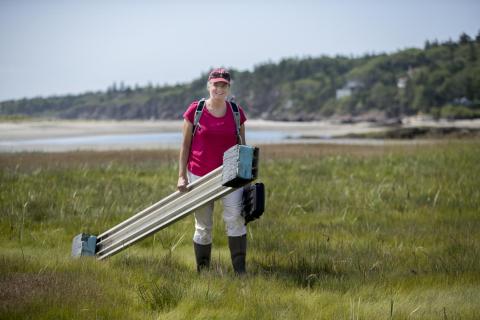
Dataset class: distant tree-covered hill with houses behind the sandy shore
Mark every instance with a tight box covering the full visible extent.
[0,33,480,121]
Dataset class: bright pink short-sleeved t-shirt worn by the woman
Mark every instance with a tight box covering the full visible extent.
[183,101,247,176]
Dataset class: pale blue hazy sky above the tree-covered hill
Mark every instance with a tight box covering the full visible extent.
[0,0,480,101]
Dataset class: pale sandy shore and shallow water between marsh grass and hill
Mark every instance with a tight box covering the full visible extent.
[0,119,480,153]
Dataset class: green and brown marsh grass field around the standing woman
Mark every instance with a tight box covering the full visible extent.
[0,140,480,320]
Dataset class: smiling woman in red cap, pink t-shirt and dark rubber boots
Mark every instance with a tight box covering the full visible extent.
[177,68,247,274]
